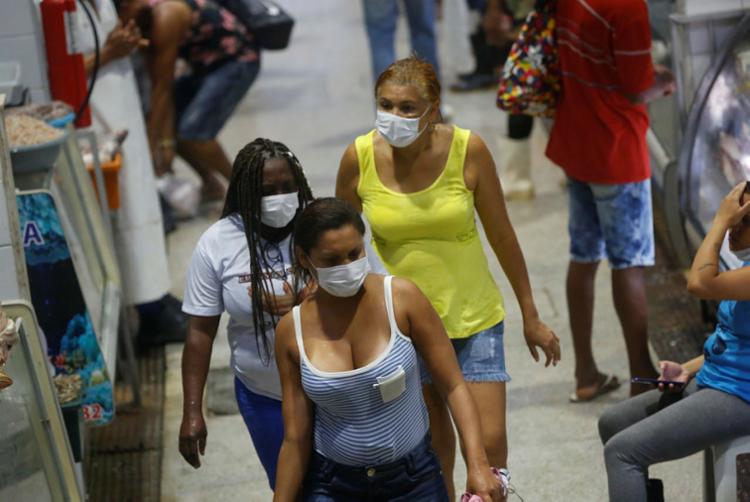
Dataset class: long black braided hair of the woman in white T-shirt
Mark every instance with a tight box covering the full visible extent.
[221,138,313,364]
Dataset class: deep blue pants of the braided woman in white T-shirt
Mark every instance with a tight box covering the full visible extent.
[234,377,284,490]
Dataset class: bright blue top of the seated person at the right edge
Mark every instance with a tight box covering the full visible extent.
[696,262,750,403]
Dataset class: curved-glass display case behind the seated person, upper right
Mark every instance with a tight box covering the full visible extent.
[647,0,750,268]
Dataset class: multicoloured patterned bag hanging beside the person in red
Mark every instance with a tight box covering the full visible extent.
[497,0,561,117]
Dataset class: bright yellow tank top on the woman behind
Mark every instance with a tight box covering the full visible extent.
[355,126,505,338]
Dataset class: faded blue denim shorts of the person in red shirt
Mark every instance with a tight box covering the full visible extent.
[568,178,654,270]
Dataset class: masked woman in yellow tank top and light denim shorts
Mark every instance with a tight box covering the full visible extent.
[336,57,560,495]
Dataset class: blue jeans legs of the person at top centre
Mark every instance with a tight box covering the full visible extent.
[362,0,440,80]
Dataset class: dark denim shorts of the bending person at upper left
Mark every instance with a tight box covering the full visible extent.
[174,61,260,141]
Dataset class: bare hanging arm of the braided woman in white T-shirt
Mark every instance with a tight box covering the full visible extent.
[179,315,219,469]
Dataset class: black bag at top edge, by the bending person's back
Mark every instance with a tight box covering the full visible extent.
[216,0,294,50]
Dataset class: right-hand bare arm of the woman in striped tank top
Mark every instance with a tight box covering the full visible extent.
[393,278,500,501]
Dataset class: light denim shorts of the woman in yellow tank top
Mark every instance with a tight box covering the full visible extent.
[419,322,510,384]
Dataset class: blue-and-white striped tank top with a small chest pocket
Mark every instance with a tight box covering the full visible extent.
[293,277,429,466]
